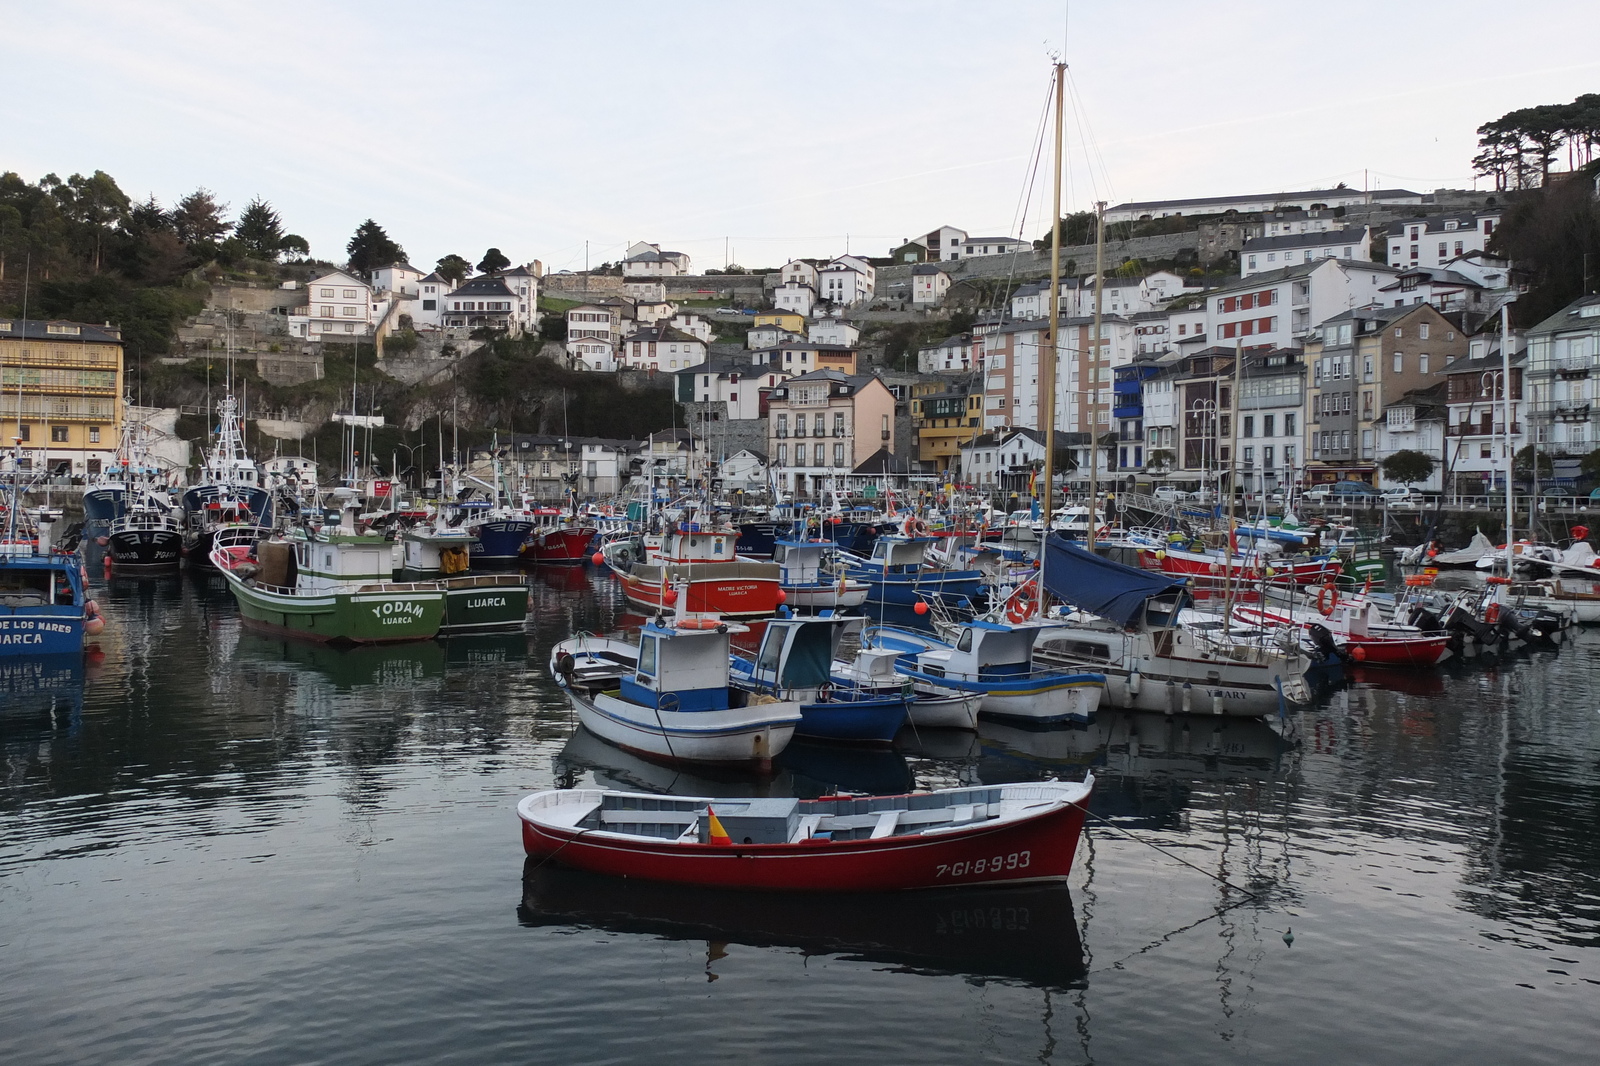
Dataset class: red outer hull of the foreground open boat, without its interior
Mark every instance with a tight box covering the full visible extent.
[518,781,1085,892]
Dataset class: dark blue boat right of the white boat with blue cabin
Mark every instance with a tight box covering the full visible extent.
[728,618,910,744]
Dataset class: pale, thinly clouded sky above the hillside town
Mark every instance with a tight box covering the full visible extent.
[0,0,1600,271]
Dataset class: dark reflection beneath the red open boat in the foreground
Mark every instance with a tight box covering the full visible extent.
[517,858,1088,989]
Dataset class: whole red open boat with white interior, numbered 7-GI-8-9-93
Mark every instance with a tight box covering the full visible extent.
[517,775,1094,892]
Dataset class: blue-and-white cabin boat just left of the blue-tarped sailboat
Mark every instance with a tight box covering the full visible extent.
[862,621,1106,723]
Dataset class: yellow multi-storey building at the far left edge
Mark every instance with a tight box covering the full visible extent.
[0,319,122,477]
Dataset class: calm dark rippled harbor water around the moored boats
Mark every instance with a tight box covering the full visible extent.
[0,568,1600,1066]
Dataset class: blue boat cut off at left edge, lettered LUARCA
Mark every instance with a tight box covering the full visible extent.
[0,470,96,656]
